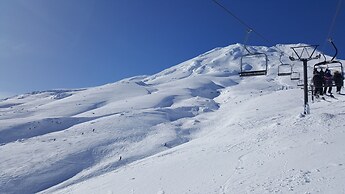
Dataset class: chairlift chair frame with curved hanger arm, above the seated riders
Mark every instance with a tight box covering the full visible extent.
[314,39,344,76]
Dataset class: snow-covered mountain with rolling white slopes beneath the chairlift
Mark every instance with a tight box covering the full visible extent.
[0,44,345,194]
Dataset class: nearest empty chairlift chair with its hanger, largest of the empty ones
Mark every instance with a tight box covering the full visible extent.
[239,30,268,77]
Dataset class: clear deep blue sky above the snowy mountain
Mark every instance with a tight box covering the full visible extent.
[0,0,345,96]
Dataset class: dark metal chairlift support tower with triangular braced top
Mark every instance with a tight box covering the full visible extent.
[289,45,320,115]
